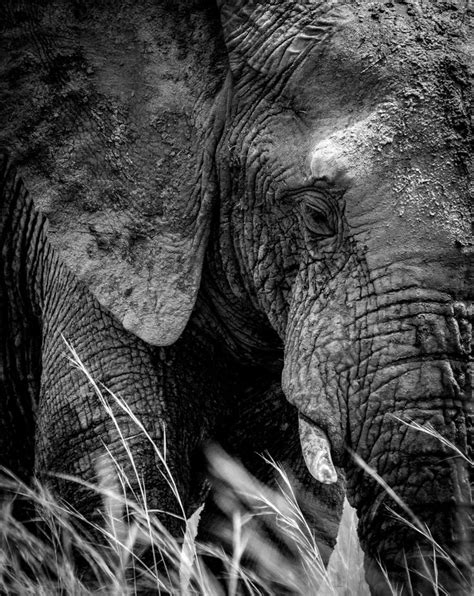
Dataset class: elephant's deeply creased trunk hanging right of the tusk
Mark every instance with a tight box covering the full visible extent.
[347,297,472,594]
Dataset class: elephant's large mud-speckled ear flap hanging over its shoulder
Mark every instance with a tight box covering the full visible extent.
[0,0,227,345]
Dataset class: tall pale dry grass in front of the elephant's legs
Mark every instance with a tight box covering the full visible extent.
[0,346,466,596]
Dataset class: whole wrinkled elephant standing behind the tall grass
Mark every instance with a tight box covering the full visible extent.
[0,0,474,595]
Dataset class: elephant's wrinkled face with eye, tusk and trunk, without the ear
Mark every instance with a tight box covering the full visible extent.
[210,2,473,594]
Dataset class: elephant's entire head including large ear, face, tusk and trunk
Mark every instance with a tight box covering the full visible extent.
[1,0,473,594]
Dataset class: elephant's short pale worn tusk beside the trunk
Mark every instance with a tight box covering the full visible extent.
[299,416,337,484]
